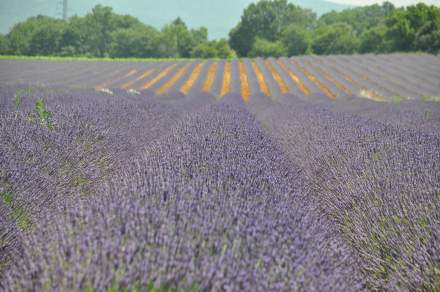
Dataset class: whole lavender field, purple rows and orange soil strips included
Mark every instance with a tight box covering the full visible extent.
[0,54,440,291]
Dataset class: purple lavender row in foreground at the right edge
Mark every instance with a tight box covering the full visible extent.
[251,98,440,291]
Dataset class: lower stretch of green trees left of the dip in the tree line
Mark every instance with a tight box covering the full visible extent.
[0,5,230,58]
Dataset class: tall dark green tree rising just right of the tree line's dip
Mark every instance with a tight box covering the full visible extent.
[229,0,316,56]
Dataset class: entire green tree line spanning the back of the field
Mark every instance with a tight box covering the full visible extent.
[0,0,440,58]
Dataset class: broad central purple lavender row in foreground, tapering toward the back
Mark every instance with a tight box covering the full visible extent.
[4,99,363,291]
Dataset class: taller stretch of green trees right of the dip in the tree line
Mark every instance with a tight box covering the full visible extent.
[237,0,440,56]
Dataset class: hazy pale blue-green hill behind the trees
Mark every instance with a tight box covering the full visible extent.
[0,0,352,38]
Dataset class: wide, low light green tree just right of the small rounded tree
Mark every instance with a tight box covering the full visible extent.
[312,23,359,55]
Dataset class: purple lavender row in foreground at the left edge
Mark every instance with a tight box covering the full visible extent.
[0,87,192,275]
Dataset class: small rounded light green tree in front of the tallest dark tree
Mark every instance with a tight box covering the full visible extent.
[281,24,311,57]
